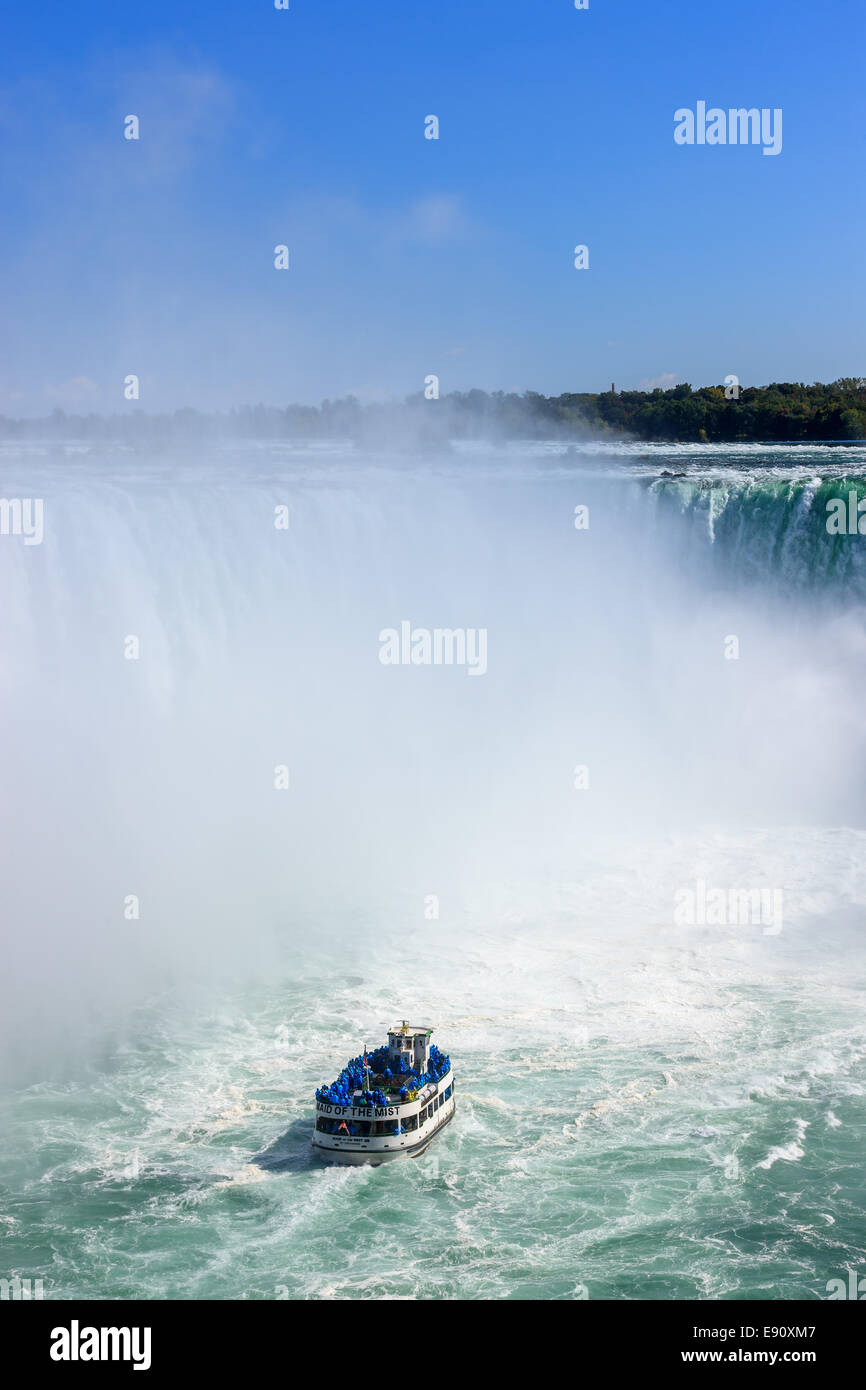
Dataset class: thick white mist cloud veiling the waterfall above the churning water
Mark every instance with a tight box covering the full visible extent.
[0,449,866,1079]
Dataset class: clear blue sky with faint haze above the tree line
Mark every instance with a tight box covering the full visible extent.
[0,0,866,414]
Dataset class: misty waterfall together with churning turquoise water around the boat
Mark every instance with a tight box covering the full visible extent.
[0,448,866,1300]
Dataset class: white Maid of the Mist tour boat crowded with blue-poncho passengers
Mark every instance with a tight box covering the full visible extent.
[313,1020,456,1165]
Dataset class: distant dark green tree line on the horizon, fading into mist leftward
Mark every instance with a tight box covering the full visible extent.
[0,377,866,448]
